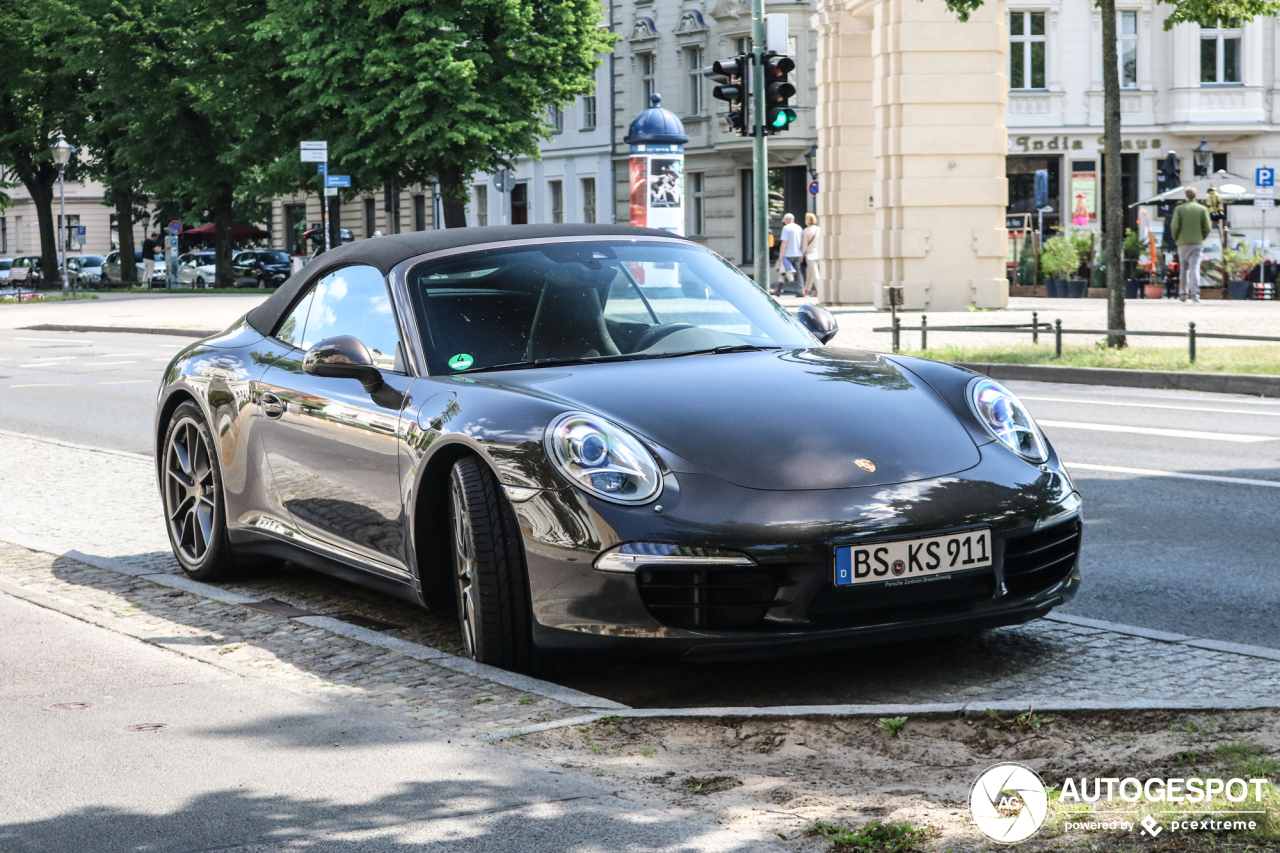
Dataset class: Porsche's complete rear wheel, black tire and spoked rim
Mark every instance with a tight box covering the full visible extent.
[161,401,241,580]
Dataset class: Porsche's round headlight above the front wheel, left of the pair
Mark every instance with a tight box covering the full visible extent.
[547,411,662,503]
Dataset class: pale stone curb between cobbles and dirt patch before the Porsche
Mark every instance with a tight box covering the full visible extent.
[477,697,1280,742]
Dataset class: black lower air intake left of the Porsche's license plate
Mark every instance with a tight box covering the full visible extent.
[636,567,790,630]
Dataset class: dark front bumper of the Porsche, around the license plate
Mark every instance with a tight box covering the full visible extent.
[515,444,1080,657]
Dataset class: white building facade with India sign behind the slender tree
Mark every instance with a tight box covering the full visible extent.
[1006,0,1280,249]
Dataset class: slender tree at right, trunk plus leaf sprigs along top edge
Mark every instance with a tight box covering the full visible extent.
[943,0,1280,347]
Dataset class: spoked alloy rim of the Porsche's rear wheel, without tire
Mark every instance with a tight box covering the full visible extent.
[165,418,218,564]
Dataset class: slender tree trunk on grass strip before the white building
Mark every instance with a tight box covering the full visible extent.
[1102,0,1126,348]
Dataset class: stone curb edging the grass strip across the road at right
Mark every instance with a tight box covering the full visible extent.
[955,361,1280,397]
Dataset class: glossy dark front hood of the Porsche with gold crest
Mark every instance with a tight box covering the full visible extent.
[476,348,980,491]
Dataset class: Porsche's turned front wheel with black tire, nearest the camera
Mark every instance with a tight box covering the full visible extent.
[449,457,536,672]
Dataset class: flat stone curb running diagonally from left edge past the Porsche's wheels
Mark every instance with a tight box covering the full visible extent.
[0,535,627,710]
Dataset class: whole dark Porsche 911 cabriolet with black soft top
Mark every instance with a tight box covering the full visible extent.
[155,225,1082,671]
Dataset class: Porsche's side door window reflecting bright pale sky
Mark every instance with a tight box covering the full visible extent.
[295,266,399,370]
